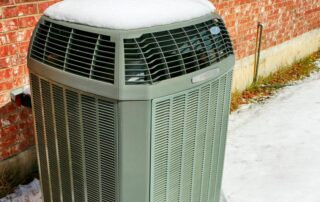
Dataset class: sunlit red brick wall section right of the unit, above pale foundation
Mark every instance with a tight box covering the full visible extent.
[211,0,320,59]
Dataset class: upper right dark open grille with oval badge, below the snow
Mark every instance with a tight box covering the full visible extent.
[124,19,233,84]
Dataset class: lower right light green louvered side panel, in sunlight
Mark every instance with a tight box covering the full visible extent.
[151,72,232,202]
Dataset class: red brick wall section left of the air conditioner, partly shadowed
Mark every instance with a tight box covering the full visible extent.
[0,0,59,160]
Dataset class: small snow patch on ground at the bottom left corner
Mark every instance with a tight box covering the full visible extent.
[0,179,42,202]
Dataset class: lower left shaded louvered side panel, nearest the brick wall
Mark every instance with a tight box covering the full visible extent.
[31,74,119,202]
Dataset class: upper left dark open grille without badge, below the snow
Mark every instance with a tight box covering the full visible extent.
[31,21,115,83]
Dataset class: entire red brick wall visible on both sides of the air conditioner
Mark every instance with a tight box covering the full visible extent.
[0,0,320,159]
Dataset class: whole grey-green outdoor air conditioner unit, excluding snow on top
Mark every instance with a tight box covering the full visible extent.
[28,11,234,202]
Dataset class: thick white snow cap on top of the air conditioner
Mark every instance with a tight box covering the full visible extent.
[45,0,215,30]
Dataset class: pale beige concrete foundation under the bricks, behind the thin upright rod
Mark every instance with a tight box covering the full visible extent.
[233,28,320,91]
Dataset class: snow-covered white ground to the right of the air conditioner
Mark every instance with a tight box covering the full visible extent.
[223,62,320,202]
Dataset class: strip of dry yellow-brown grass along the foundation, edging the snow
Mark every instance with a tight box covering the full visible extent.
[231,50,320,111]
